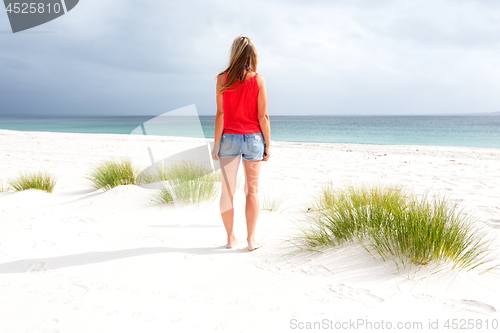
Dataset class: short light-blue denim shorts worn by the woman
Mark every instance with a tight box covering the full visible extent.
[219,132,266,161]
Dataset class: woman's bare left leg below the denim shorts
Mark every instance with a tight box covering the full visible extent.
[219,155,241,249]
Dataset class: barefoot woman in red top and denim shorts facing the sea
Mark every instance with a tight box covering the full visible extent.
[212,36,271,251]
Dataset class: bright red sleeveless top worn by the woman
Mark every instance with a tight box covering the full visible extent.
[222,73,262,134]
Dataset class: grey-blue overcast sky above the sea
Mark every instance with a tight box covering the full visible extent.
[0,0,500,116]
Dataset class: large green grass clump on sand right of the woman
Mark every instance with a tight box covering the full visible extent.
[301,183,490,270]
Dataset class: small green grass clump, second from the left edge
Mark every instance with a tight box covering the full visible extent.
[87,159,138,191]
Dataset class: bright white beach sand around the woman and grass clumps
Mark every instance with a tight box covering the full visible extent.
[0,130,500,333]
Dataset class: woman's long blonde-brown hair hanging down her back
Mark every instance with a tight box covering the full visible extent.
[216,35,257,96]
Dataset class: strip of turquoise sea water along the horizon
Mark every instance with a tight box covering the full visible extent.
[0,116,500,148]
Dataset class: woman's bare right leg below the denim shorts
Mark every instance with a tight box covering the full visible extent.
[243,161,262,251]
